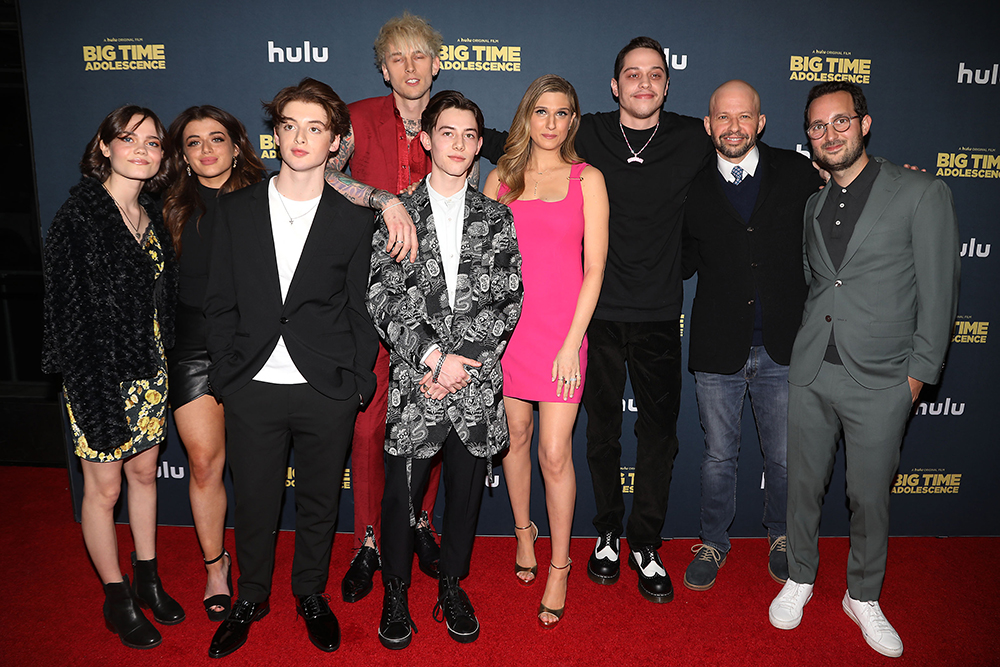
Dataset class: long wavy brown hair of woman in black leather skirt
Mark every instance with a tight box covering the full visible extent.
[163,104,264,256]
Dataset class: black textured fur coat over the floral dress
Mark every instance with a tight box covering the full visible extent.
[42,178,177,452]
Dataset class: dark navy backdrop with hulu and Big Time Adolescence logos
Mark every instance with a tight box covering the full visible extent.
[20,0,1000,538]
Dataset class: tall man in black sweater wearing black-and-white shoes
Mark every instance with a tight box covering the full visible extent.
[482,37,712,603]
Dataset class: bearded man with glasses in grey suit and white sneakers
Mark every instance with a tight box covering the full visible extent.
[769,81,959,657]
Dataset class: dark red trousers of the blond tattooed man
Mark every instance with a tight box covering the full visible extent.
[351,344,441,540]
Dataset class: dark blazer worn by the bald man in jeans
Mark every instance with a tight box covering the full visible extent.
[683,142,823,374]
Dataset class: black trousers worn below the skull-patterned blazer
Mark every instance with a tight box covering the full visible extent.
[381,429,486,586]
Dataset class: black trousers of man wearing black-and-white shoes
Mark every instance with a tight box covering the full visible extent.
[583,320,681,549]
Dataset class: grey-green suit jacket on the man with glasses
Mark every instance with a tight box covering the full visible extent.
[788,157,959,389]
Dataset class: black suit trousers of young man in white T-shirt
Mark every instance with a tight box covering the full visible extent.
[223,382,358,602]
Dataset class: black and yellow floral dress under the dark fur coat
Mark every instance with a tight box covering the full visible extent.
[63,227,167,463]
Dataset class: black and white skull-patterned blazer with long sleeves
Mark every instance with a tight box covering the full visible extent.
[368,179,523,468]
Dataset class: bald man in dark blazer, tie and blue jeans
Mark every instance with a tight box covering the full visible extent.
[683,81,822,591]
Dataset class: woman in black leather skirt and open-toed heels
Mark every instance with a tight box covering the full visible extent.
[163,106,264,621]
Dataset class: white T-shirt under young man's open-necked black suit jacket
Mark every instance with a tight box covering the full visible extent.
[253,178,323,384]
